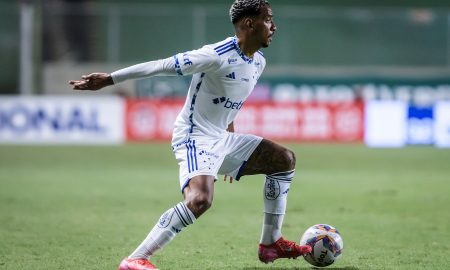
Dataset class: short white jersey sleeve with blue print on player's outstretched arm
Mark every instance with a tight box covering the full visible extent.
[173,46,220,75]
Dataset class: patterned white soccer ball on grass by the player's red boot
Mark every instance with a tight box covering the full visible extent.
[300,224,344,267]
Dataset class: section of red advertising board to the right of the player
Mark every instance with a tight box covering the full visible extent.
[235,103,364,142]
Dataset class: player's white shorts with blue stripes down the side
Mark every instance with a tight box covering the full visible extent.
[172,132,262,192]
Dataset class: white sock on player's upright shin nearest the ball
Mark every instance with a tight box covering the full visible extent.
[260,170,295,245]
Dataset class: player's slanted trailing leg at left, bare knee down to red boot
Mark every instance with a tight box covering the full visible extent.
[119,175,214,270]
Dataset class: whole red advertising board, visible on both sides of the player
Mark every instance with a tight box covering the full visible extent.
[125,99,364,142]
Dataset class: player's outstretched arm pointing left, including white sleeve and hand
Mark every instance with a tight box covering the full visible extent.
[69,46,220,90]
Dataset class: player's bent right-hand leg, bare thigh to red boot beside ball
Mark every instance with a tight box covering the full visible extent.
[241,139,311,263]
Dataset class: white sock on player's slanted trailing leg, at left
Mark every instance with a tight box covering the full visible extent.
[129,202,195,259]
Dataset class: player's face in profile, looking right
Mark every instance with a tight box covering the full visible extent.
[254,6,277,48]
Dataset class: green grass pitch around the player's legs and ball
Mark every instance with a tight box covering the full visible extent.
[0,144,450,270]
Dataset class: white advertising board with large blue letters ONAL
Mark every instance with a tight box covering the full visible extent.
[0,96,124,144]
